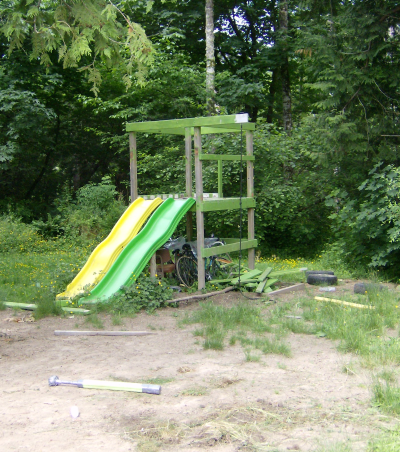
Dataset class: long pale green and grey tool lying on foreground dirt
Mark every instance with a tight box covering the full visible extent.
[49,375,161,394]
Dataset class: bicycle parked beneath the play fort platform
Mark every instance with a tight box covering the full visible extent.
[174,237,233,288]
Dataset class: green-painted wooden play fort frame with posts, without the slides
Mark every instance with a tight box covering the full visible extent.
[126,114,257,289]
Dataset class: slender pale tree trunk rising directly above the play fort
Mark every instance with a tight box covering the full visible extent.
[206,0,216,116]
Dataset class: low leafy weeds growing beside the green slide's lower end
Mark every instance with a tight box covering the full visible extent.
[107,274,173,315]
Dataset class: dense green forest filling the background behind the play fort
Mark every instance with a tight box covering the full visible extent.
[0,0,400,278]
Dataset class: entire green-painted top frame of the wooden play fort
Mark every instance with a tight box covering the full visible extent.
[126,113,255,135]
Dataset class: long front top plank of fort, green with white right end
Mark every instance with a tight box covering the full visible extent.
[126,114,249,132]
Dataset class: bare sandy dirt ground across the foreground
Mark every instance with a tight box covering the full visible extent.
[0,281,390,452]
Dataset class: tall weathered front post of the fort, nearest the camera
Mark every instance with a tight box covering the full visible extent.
[194,127,206,290]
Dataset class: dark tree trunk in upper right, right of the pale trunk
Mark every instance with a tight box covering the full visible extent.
[279,0,293,133]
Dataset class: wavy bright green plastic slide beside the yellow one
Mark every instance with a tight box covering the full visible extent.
[80,198,196,304]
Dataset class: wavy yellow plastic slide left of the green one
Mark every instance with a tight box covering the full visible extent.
[56,198,162,299]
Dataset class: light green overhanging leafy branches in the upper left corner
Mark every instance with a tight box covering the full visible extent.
[0,0,153,95]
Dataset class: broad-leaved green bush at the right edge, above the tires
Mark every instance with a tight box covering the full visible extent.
[327,164,400,277]
